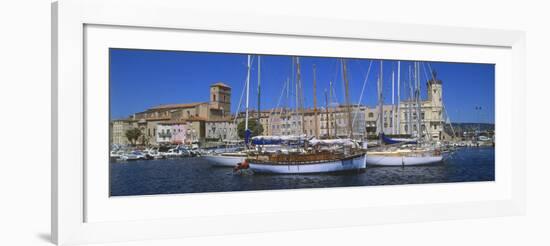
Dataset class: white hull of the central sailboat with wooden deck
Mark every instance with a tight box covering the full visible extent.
[249,154,366,174]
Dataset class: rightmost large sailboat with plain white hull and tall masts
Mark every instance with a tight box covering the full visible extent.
[366,61,443,166]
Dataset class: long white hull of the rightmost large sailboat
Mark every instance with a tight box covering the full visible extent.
[366,153,443,166]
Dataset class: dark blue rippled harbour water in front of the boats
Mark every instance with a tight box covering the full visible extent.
[110,148,495,196]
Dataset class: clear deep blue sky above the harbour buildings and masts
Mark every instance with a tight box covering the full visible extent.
[109,49,495,123]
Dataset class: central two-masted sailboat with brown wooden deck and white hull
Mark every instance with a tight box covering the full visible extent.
[243,58,366,174]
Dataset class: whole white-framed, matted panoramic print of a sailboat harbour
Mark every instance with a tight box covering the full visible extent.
[52,0,525,244]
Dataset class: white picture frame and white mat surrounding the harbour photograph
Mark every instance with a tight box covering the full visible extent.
[52,0,526,244]
